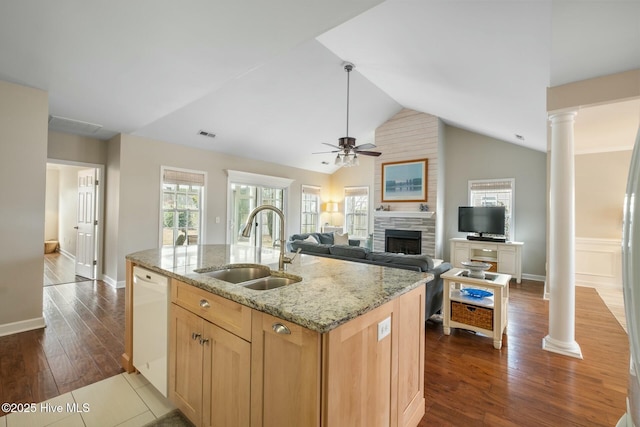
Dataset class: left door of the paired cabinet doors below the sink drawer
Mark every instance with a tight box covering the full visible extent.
[169,304,204,425]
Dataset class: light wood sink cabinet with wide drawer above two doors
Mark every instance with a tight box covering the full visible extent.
[169,281,251,427]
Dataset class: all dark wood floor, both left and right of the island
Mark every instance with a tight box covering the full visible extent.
[0,281,629,426]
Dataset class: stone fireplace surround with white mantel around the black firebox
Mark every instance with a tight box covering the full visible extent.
[373,211,436,258]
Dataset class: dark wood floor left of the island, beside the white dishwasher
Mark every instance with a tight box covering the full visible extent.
[0,281,124,415]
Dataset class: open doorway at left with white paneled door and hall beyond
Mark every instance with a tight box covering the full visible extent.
[43,160,104,286]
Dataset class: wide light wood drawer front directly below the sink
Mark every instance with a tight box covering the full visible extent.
[171,279,251,341]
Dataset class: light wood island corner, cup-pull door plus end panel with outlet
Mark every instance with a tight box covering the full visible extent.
[251,287,425,427]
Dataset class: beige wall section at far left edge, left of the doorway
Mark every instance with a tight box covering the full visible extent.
[0,81,49,335]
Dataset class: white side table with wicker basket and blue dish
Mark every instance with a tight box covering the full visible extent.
[440,268,511,349]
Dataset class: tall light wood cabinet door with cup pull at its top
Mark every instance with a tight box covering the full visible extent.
[251,311,320,427]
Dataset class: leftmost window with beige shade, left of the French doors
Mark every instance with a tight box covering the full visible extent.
[160,167,206,246]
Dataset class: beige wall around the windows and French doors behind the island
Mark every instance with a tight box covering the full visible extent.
[104,135,330,281]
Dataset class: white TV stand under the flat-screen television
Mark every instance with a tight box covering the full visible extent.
[450,237,524,283]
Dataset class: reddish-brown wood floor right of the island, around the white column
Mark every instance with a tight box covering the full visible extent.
[420,281,629,427]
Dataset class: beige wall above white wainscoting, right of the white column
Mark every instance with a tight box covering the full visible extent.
[575,151,631,239]
